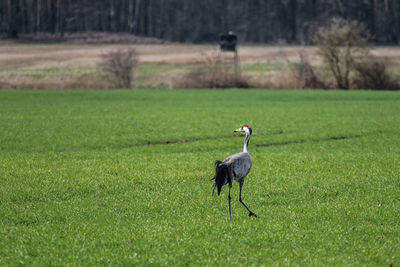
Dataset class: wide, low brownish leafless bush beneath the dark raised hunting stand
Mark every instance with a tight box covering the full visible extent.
[174,53,250,88]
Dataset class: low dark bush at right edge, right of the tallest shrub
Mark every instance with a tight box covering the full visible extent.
[353,58,400,90]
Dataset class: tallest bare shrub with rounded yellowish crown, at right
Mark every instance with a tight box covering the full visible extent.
[315,18,369,89]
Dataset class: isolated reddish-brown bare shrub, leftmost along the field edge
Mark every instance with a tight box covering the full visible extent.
[99,48,139,88]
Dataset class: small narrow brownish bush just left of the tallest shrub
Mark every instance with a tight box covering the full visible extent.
[290,53,327,89]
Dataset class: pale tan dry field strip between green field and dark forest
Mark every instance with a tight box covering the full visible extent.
[0,42,400,90]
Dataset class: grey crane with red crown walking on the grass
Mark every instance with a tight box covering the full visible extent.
[211,125,257,220]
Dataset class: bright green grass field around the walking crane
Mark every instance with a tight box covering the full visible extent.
[0,90,400,266]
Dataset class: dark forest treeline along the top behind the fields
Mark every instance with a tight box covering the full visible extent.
[0,0,400,44]
